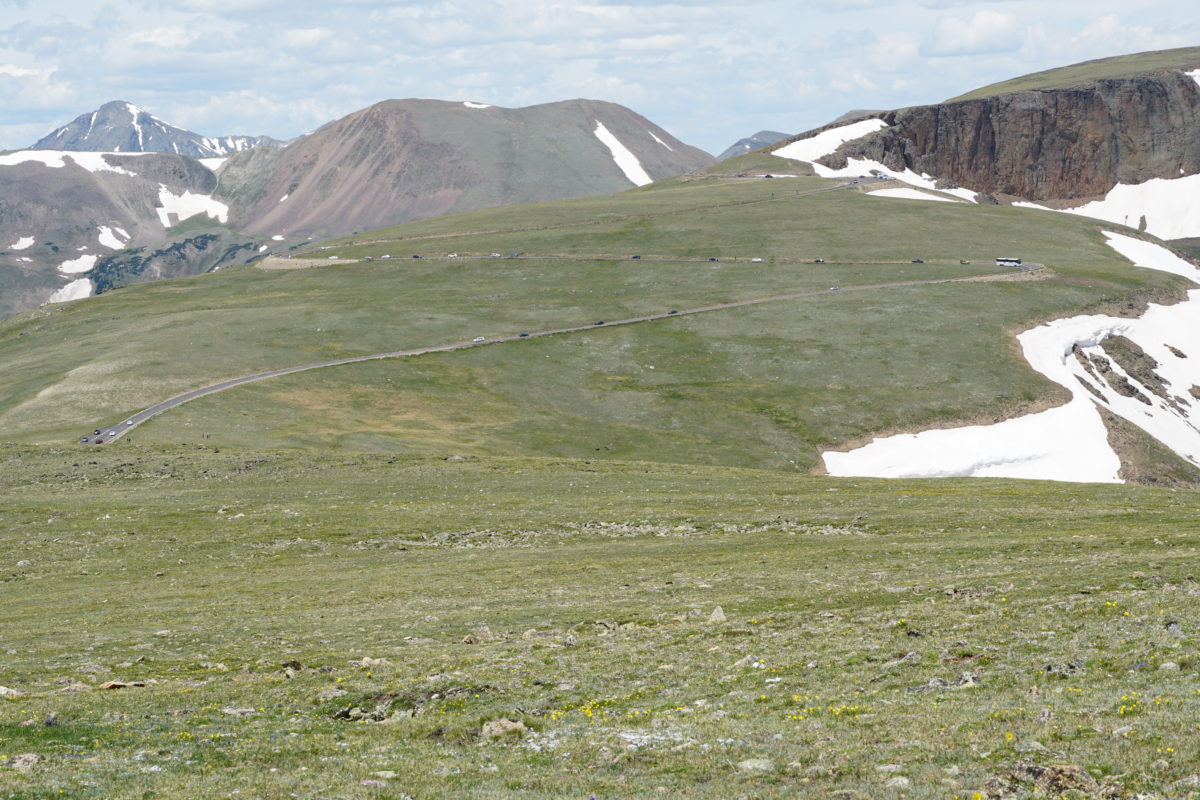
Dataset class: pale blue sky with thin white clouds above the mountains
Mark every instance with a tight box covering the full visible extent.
[0,0,1200,155]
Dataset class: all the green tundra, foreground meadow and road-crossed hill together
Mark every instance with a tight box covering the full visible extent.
[0,106,1200,800]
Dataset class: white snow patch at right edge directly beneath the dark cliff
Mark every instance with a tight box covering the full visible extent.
[1013,173,1200,239]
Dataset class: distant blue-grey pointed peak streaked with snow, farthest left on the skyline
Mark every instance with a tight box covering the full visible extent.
[31,100,283,158]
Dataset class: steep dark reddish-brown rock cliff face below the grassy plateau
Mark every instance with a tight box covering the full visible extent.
[821,70,1200,200]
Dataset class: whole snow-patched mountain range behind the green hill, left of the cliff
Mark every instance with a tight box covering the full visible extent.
[0,100,713,315]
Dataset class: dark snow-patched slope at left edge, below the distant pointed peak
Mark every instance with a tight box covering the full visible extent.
[0,150,250,317]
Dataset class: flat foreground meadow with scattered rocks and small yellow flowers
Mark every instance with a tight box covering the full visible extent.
[0,443,1200,800]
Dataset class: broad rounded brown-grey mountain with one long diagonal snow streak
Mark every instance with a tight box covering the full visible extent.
[217,100,714,241]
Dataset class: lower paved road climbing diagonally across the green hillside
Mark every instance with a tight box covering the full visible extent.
[80,264,1042,445]
